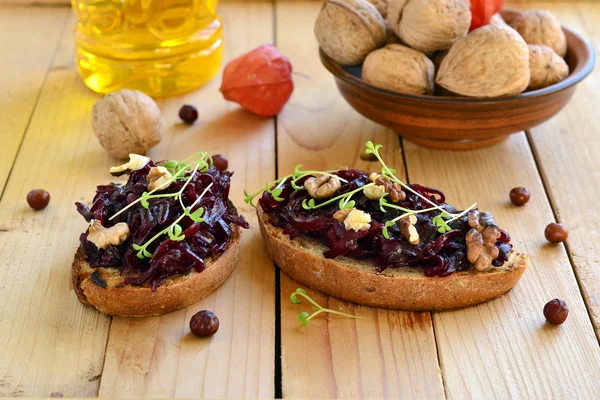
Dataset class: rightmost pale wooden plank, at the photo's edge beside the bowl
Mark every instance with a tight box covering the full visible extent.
[512,3,600,335]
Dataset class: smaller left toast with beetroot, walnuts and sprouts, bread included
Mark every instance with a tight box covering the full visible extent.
[73,153,249,317]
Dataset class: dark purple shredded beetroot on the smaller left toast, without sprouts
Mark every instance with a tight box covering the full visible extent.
[75,161,250,291]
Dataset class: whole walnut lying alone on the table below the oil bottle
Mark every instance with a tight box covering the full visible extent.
[92,89,163,158]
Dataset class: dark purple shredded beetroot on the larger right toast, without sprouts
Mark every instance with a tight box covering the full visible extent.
[259,169,512,276]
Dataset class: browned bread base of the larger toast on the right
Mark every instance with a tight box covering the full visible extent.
[257,205,529,311]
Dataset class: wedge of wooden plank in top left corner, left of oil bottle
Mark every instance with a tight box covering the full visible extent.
[0,7,70,195]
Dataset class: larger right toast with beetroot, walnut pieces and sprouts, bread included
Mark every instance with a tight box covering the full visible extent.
[246,142,529,310]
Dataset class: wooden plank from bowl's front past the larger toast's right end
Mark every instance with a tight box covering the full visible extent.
[405,133,600,398]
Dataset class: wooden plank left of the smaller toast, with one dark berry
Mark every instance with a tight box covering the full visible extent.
[0,14,113,397]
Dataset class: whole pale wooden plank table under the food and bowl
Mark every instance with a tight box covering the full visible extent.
[0,0,600,399]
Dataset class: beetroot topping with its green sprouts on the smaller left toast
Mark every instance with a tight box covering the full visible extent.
[75,153,249,291]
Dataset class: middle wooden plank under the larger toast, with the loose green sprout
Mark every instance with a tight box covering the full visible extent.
[276,1,444,398]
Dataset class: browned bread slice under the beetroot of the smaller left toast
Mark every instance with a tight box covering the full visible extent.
[73,225,240,317]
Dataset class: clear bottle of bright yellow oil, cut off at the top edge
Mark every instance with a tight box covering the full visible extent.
[71,0,223,97]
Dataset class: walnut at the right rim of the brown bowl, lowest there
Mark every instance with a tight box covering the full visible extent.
[527,44,569,90]
